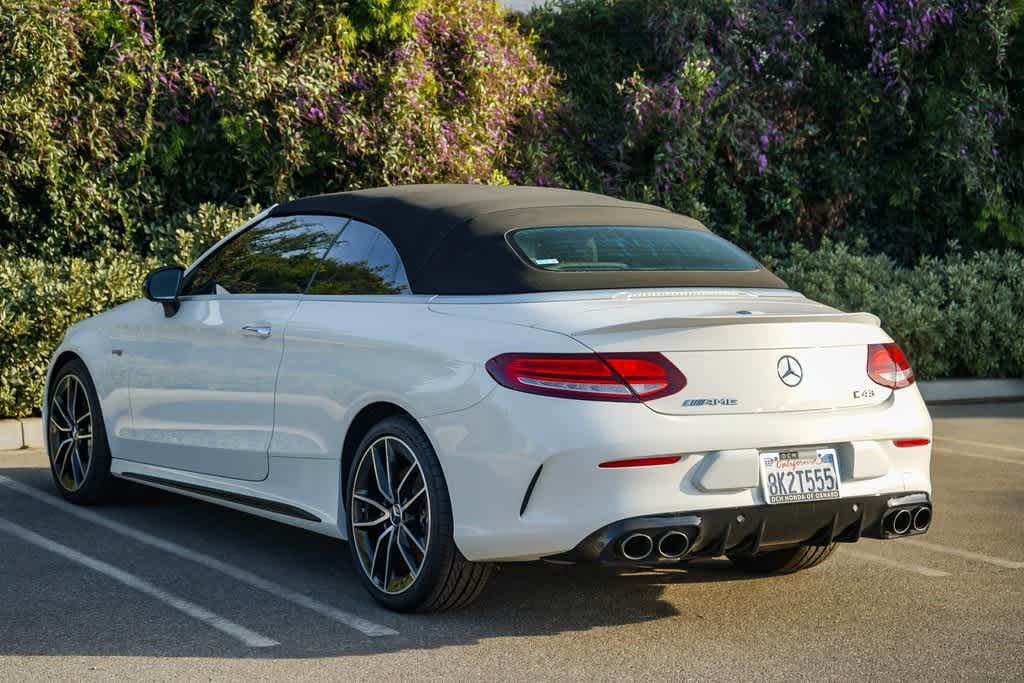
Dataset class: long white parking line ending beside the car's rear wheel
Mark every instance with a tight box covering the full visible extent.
[0,475,398,637]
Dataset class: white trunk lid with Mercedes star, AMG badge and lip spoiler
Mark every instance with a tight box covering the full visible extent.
[431,290,892,417]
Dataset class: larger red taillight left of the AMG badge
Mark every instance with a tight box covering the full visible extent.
[486,353,686,401]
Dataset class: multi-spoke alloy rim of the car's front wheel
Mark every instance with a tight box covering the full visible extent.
[47,375,93,492]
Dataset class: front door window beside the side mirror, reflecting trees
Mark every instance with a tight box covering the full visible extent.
[181,216,348,296]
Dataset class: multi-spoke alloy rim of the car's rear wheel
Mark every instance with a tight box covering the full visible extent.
[349,436,430,595]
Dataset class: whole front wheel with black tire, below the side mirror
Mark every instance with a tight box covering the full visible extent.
[46,358,117,505]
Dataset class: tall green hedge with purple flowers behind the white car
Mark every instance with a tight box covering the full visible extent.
[0,0,1024,415]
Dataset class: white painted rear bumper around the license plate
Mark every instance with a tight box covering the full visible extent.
[420,386,932,561]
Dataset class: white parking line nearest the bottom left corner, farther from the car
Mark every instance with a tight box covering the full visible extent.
[0,518,281,647]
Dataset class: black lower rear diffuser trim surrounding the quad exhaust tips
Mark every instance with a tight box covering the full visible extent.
[545,492,932,564]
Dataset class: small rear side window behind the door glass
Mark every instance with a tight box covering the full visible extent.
[308,220,409,294]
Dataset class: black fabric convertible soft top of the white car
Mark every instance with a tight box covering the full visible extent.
[269,184,785,295]
